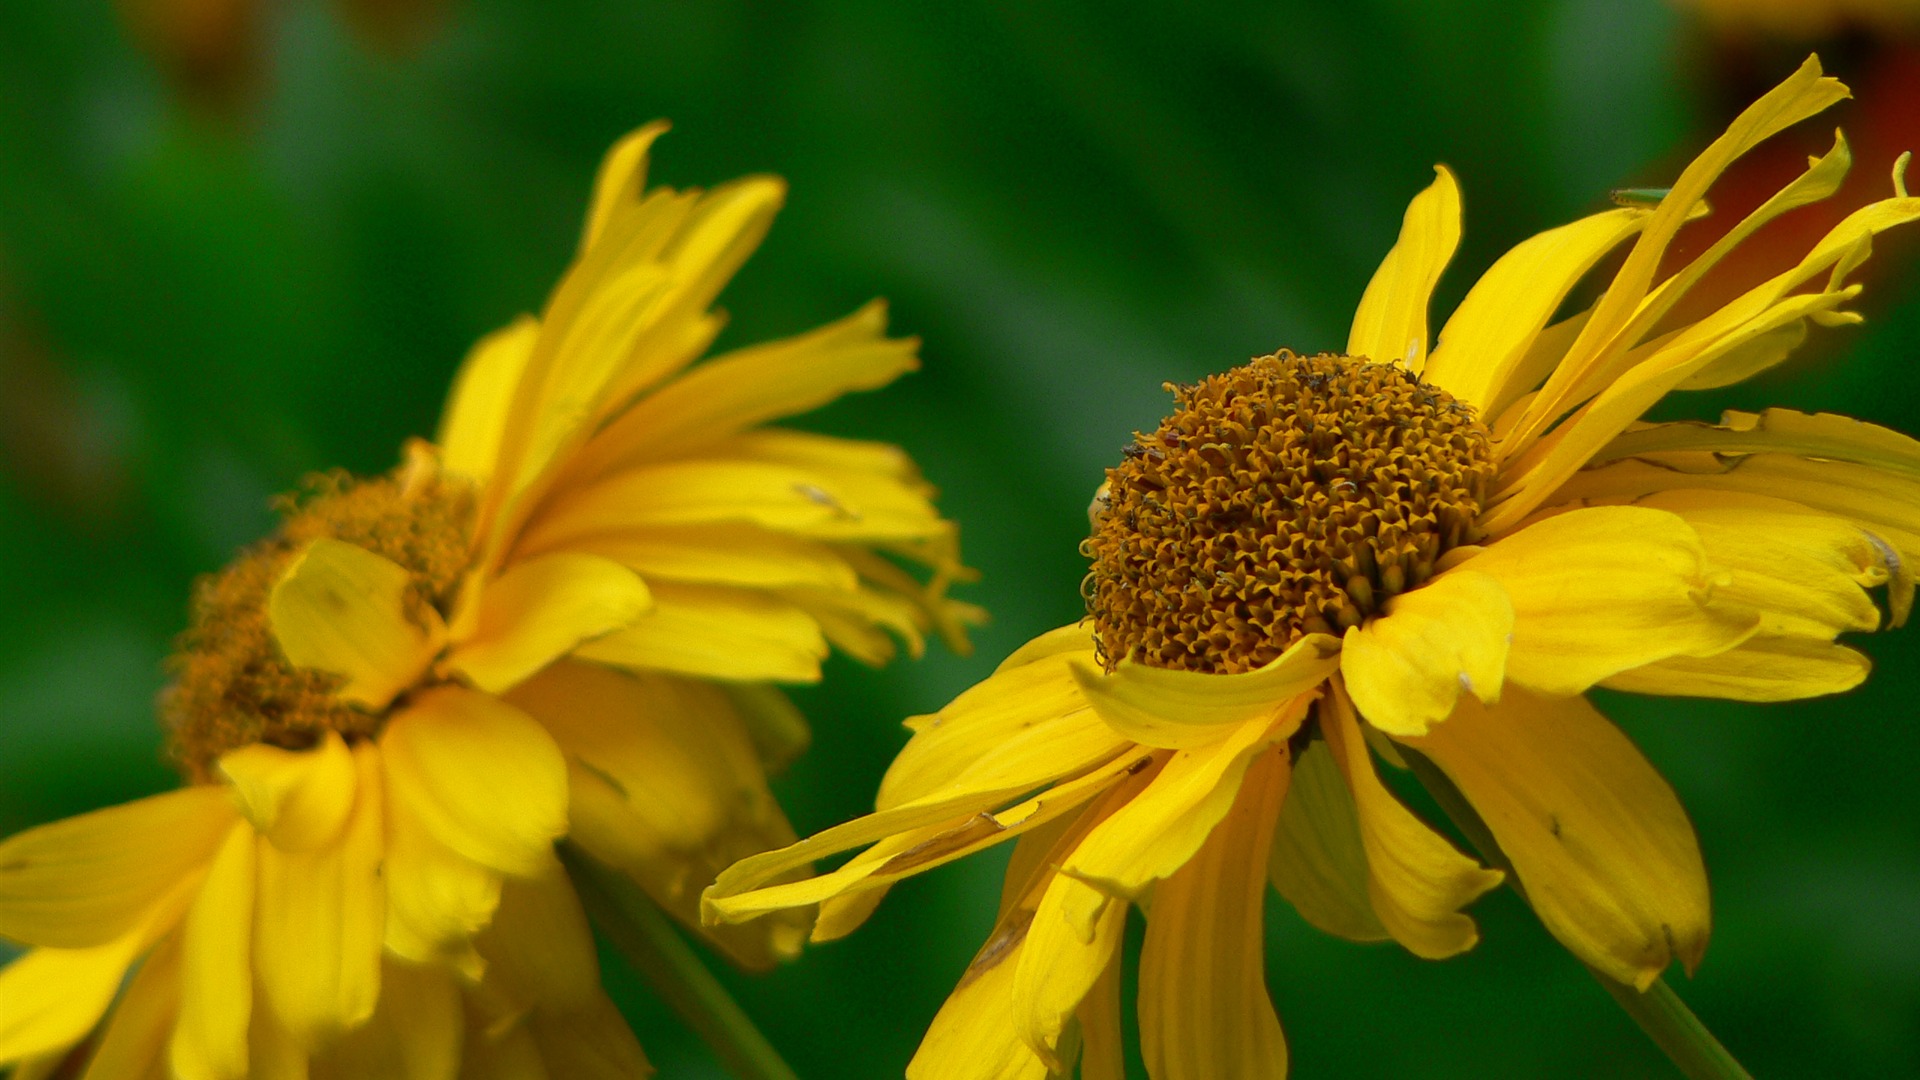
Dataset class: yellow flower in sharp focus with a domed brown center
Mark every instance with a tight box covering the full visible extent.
[707,60,1920,1080]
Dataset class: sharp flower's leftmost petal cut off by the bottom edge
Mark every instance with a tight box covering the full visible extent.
[906,914,1050,1080]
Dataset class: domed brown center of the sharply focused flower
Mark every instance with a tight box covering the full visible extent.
[1083,350,1494,675]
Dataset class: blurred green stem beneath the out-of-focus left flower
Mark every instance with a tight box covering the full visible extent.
[561,844,797,1080]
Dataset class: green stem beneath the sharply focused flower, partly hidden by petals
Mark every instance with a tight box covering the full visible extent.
[1400,746,1753,1080]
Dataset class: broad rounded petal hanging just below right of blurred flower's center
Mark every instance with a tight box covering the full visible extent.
[380,686,566,874]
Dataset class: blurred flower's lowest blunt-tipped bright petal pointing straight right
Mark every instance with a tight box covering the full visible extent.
[576,582,828,682]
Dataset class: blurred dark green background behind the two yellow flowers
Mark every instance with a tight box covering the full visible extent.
[0,0,1920,1078]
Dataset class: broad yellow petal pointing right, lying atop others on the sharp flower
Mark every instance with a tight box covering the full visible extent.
[1463,505,1759,694]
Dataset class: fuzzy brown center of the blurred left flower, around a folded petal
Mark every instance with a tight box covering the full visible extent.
[159,461,474,782]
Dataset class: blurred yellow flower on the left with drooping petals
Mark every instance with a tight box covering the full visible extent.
[0,125,975,1080]
